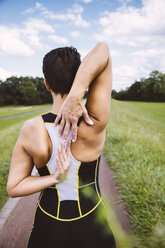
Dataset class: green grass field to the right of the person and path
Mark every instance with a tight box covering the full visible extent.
[104,100,165,248]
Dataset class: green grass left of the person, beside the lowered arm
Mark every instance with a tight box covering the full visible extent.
[0,105,51,209]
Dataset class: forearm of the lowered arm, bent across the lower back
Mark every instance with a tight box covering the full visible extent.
[7,175,58,197]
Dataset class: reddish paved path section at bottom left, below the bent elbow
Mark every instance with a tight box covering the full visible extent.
[0,193,38,248]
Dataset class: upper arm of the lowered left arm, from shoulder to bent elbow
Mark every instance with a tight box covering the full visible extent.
[7,123,33,192]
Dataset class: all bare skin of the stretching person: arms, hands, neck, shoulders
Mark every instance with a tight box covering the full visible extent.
[7,43,112,197]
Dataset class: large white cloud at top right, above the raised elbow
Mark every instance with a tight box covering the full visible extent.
[95,0,165,47]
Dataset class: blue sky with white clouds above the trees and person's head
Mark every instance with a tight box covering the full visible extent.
[0,0,165,91]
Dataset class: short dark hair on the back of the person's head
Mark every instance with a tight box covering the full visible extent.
[42,47,81,96]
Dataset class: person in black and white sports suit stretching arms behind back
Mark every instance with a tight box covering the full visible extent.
[7,43,116,248]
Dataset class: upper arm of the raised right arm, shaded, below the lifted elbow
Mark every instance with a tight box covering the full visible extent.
[86,52,112,130]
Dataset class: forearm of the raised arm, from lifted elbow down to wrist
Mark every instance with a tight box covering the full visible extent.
[68,43,110,100]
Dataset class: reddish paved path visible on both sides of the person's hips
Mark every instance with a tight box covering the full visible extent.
[0,157,130,248]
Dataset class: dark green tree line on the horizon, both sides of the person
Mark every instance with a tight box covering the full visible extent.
[0,71,165,106]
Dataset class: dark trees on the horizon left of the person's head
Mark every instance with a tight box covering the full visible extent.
[0,77,52,106]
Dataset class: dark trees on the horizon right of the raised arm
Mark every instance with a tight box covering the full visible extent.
[112,71,165,102]
